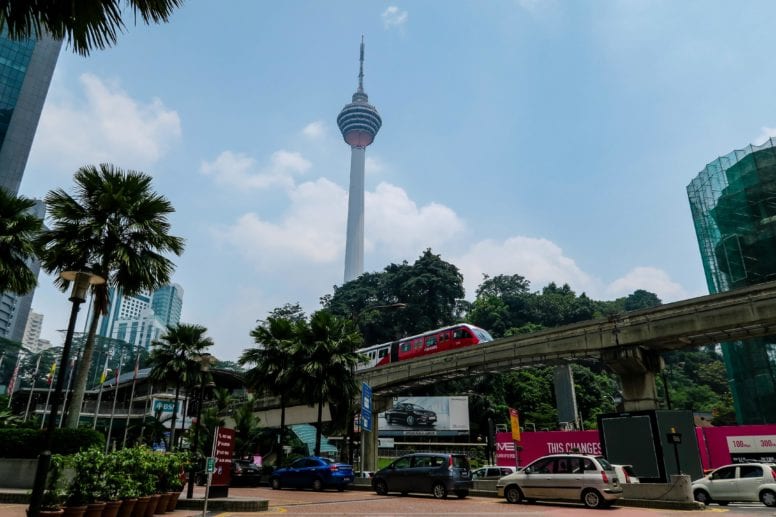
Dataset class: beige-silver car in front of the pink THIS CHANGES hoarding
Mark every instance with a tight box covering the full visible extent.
[496,454,622,508]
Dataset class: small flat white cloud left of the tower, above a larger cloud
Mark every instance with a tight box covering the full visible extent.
[200,150,311,189]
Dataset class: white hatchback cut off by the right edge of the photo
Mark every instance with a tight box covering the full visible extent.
[692,463,776,506]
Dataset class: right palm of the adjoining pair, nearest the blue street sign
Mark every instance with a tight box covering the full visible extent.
[296,310,366,456]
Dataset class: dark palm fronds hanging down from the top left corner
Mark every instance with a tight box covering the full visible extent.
[0,0,183,56]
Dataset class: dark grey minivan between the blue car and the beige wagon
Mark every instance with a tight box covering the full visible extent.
[372,453,474,499]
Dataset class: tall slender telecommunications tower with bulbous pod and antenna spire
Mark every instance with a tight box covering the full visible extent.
[337,36,383,282]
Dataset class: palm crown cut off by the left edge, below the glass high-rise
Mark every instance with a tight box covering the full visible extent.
[0,187,43,294]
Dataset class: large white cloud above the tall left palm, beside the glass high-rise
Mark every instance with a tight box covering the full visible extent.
[31,73,181,174]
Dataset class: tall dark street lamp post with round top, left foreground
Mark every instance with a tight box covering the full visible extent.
[27,271,105,517]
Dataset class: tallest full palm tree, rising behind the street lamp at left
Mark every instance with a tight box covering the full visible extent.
[36,164,183,429]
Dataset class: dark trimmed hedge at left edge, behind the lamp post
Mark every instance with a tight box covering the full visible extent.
[0,427,105,458]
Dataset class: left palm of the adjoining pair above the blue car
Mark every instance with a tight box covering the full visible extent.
[238,317,304,466]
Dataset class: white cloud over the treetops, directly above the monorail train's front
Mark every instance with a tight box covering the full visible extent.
[452,236,595,299]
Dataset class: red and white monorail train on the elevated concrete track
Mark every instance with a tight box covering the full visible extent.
[358,323,493,370]
